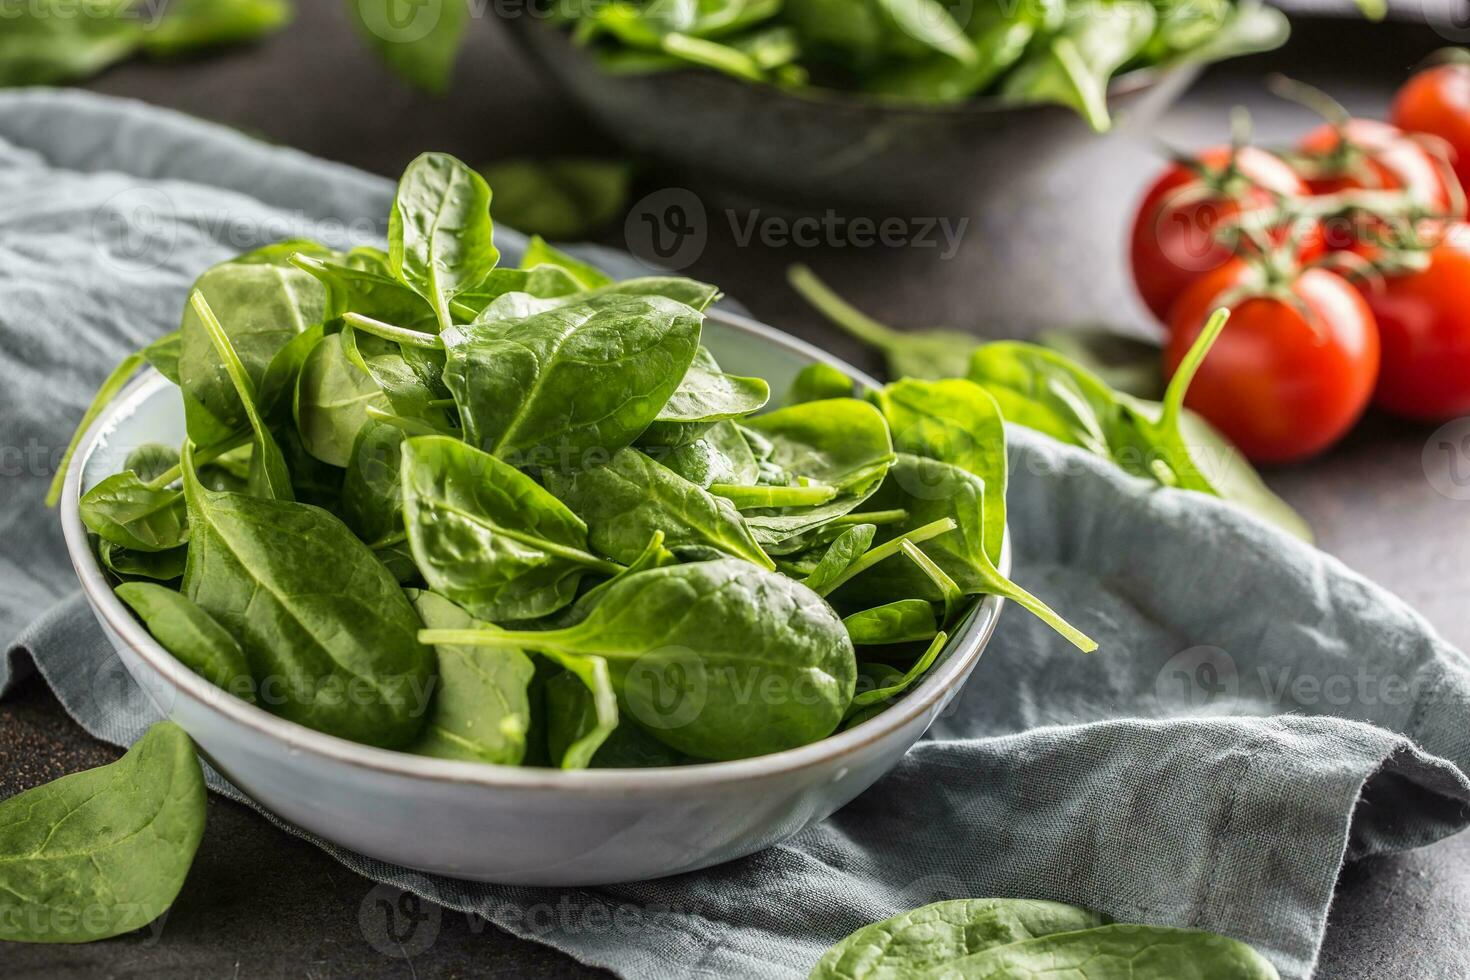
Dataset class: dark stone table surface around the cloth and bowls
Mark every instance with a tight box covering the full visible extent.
[0,0,1470,980]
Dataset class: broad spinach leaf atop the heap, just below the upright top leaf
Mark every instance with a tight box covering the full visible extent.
[444,295,703,469]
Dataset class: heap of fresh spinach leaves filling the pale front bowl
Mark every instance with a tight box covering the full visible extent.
[53,154,1094,768]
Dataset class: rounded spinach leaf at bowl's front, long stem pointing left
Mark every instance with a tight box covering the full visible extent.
[422,558,857,760]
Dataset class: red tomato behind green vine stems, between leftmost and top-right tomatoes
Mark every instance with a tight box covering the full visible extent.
[1298,119,1464,248]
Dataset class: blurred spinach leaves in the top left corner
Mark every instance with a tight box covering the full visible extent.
[0,0,294,85]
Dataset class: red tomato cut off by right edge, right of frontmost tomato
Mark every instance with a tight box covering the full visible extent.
[1363,225,1470,422]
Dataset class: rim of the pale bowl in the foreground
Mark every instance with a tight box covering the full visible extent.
[60,310,1011,793]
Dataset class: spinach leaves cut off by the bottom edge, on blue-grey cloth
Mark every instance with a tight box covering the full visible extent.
[810,898,1277,980]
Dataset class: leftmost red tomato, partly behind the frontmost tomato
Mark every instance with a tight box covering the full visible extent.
[1129,147,1322,322]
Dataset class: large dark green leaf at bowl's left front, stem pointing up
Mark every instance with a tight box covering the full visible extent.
[182,442,434,748]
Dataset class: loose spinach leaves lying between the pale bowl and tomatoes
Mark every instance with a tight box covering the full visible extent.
[789,266,1311,542]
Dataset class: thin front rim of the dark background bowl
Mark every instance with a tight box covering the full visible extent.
[501,11,1181,118]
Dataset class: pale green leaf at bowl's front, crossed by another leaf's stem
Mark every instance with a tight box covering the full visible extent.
[409,592,535,765]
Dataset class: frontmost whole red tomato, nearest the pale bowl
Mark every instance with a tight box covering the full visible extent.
[1164,262,1379,463]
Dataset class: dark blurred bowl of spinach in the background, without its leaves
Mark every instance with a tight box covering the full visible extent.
[506,18,1198,210]
